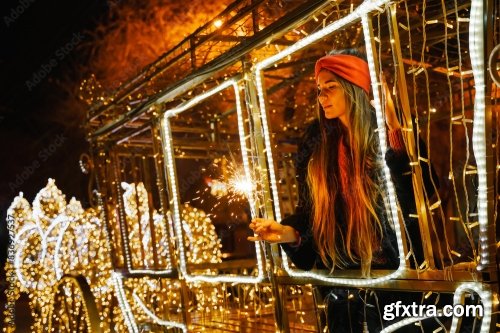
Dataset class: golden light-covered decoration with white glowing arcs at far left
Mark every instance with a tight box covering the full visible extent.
[7,179,115,332]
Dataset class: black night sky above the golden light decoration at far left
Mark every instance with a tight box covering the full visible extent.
[0,0,110,267]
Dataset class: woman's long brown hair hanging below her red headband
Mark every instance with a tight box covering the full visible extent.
[307,50,382,277]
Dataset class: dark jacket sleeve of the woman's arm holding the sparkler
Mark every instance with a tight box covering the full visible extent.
[281,121,320,270]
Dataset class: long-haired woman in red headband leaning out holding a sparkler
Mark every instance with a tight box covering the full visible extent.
[249,50,428,332]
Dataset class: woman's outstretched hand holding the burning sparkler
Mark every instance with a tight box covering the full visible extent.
[247,218,298,243]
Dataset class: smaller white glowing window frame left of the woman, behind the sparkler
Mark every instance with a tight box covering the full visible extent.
[161,78,264,283]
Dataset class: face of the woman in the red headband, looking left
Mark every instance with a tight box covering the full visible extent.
[317,70,348,125]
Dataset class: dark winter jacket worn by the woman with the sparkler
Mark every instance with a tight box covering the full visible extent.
[281,121,434,270]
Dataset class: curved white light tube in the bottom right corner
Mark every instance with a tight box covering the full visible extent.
[380,282,493,333]
